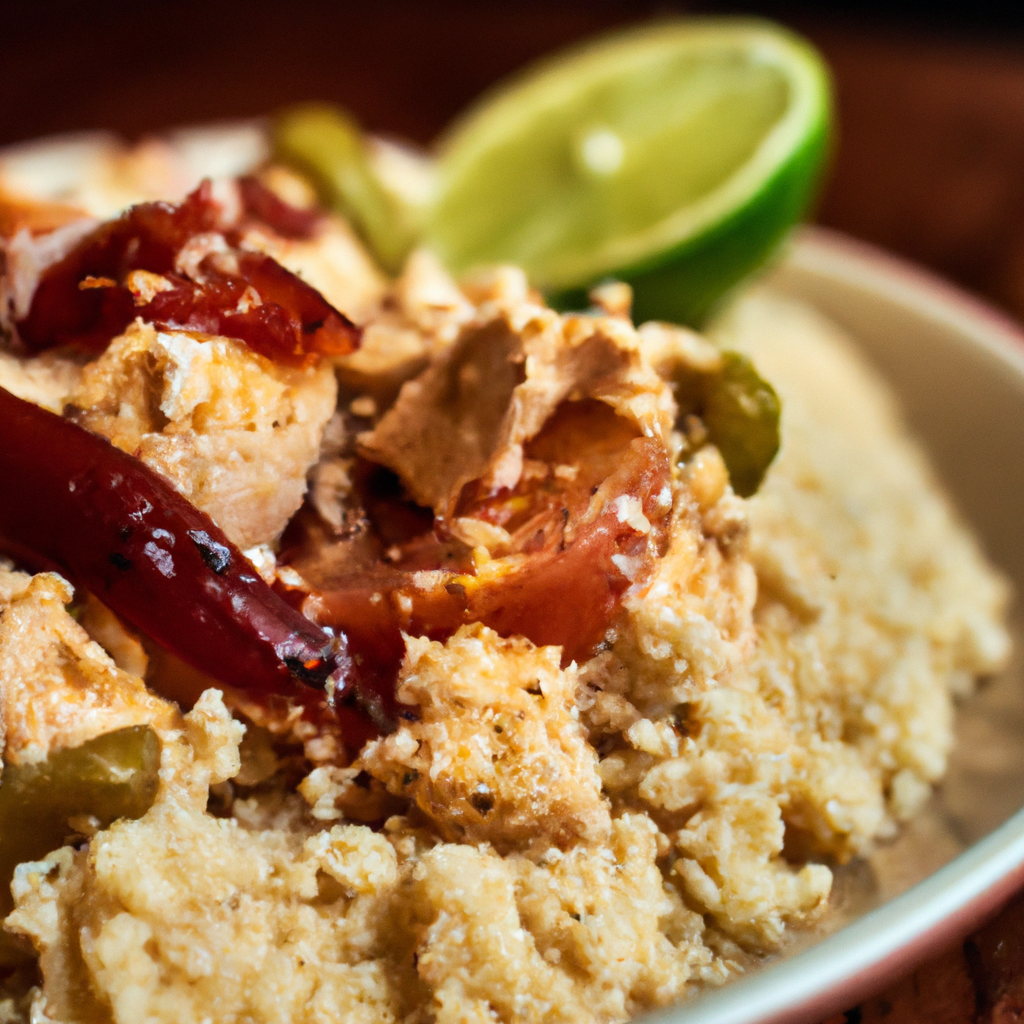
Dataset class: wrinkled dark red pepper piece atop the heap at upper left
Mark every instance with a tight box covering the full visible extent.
[15,181,359,366]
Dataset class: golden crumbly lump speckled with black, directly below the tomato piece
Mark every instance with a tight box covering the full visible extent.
[360,626,611,853]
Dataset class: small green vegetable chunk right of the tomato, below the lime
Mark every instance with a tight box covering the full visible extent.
[676,352,781,498]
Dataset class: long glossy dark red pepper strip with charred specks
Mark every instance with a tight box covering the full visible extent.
[0,380,380,738]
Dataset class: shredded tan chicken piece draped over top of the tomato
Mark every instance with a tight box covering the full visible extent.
[359,303,673,516]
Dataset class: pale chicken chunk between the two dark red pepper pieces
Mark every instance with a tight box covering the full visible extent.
[70,322,337,549]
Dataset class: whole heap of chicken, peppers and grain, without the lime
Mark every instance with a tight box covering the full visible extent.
[0,121,1009,1024]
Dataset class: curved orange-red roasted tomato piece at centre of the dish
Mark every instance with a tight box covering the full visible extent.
[286,401,672,674]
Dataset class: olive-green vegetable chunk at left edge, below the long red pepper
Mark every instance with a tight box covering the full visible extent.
[0,725,160,966]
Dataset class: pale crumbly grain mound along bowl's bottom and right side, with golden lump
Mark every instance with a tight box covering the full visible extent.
[0,293,1008,1024]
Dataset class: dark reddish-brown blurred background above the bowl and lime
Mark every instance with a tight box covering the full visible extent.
[0,0,1024,319]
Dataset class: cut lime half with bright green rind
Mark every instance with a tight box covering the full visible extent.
[427,18,830,324]
